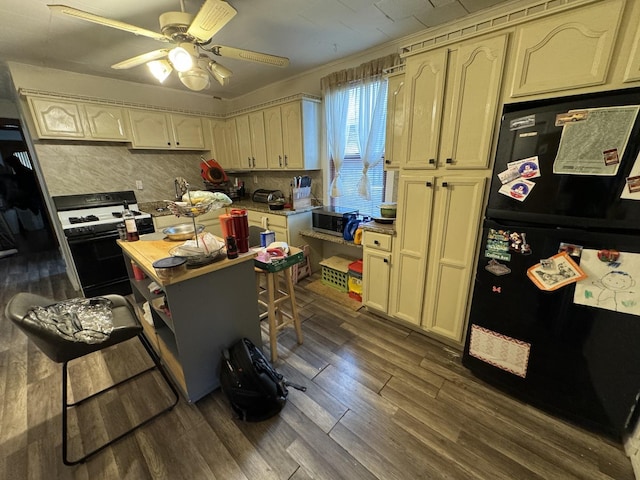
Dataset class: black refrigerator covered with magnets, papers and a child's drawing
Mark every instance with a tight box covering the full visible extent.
[463,89,640,440]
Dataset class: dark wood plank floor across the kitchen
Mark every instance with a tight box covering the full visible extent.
[0,251,633,480]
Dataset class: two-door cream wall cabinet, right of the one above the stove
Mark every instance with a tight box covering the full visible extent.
[129,109,205,150]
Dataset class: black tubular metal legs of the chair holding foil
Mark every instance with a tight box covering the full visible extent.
[62,333,180,466]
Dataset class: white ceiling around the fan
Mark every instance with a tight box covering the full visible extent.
[0,0,504,98]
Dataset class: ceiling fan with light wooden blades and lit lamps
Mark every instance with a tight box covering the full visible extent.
[47,0,289,91]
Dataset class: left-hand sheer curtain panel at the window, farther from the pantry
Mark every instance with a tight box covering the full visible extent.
[324,85,349,197]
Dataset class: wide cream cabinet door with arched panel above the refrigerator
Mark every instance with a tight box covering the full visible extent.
[511,0,625,97]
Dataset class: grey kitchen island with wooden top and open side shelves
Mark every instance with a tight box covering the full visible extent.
[118,233,262,402]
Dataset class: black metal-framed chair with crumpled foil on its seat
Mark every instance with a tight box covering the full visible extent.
[5,292,179,465]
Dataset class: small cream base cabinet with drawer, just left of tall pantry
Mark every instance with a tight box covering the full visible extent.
[362,230,393,313]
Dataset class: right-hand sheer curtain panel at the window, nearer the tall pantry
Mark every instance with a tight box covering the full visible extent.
[358,78,387,200]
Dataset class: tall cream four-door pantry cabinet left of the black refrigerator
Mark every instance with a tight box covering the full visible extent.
[390,34,507,343]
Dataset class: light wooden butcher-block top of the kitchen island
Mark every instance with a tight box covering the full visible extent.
[117,233,255,286]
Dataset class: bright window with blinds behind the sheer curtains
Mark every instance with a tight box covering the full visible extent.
[330,80,387,216]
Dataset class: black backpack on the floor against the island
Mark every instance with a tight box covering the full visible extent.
[220,338,306,422]
